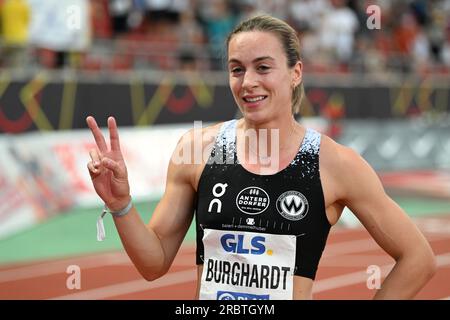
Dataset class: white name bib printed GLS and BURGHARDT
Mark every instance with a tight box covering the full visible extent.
[200,229,296,300]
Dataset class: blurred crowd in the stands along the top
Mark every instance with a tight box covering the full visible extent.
[0,0,450,74]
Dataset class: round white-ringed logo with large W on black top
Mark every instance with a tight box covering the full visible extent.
[276,191,309,221]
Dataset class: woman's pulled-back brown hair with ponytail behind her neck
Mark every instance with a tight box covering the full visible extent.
[227,15,303,114]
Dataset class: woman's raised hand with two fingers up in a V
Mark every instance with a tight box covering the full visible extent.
[86,116,130,211]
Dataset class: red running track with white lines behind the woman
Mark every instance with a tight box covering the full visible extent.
[0,215,450,300]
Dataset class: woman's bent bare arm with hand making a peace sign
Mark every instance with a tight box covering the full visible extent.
[86,117,195,280]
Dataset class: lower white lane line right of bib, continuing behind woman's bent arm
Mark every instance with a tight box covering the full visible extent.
[313,253,450,294]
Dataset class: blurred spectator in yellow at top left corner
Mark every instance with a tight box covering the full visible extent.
[0,0,31,68]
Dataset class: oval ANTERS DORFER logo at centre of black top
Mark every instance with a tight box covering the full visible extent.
[236,187,270,215]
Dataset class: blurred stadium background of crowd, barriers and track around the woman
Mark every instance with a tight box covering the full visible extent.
[0,0,450,299]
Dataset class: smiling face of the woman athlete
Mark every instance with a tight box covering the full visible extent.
[228,31,301,123]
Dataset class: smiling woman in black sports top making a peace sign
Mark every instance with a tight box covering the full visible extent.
[87,15,436,299]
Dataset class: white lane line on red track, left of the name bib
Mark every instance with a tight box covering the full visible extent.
[50,269,197,300]
